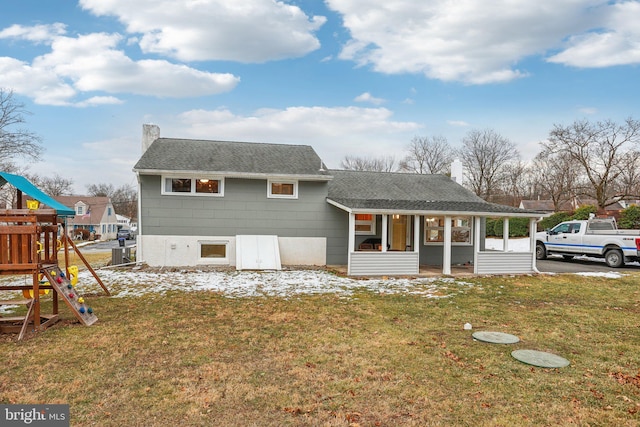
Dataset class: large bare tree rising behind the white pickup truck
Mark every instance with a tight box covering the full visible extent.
[543,118,640,209]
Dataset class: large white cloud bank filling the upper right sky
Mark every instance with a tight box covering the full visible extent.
[326,0,640,84]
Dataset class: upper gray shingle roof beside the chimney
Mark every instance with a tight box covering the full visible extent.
[133,138,329,177]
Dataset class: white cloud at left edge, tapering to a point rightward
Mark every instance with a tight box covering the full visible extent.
[0,29,239,106]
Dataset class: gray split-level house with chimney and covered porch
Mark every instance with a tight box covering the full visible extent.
[133,125,544,275]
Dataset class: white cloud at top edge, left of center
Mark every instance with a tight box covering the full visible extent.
[80,0,326,63]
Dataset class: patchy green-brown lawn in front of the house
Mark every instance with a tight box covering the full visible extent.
[0,275,640,426]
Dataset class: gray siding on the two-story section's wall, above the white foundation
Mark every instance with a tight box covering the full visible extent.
[140,175,348,264]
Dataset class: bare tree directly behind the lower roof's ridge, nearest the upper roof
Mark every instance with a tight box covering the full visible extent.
[400,136,454,174]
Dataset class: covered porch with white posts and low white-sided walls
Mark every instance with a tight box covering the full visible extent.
[347,210,539,276]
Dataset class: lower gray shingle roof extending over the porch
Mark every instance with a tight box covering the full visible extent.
[328,170,542,216]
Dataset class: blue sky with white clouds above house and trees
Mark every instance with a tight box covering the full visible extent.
[0,0,640,193]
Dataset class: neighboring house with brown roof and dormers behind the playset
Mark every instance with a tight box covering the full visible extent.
[53,196,118,240]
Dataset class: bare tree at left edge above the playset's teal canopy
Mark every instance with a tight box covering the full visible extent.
[0,88,42,169]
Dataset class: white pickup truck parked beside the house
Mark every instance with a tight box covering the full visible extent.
[536,218,640,267]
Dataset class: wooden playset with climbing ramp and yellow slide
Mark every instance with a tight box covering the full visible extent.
[0,174,110,340]
